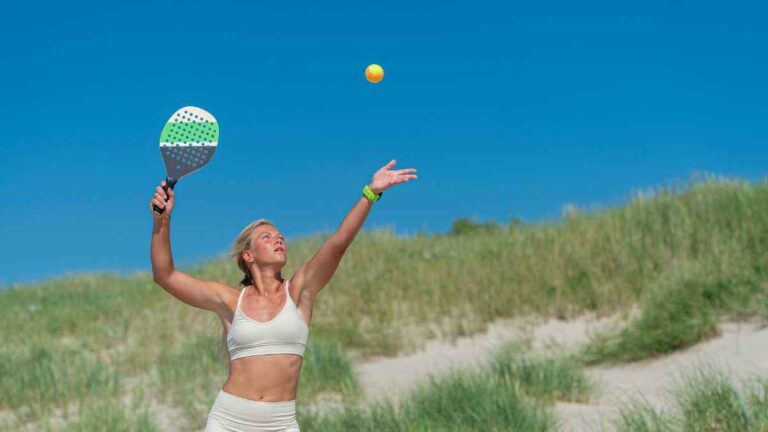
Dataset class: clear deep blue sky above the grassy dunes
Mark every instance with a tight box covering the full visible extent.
[0,1,768,285]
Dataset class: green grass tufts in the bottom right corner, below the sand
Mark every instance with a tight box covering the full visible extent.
[615,367,768,432]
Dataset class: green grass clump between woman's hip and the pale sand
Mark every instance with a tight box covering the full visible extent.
[299,346,593,431]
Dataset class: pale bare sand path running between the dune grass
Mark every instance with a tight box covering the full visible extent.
[355,317,768,431]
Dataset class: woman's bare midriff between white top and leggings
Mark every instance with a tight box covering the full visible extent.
[222,354,304,402]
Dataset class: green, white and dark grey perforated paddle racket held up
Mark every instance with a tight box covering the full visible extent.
[152,106,219,214]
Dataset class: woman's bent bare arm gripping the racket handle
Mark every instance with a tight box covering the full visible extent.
[149,181,236,319]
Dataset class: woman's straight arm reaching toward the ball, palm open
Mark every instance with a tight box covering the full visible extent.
[292,160,416,298]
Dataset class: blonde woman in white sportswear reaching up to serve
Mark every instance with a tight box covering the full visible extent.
[149,160,416,432]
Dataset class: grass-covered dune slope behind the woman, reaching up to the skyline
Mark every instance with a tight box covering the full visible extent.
[0,179,768,425]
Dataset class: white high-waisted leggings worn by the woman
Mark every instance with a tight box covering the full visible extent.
[203,390,300,432]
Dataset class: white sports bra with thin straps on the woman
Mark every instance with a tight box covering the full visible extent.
[227,279,309,360]
